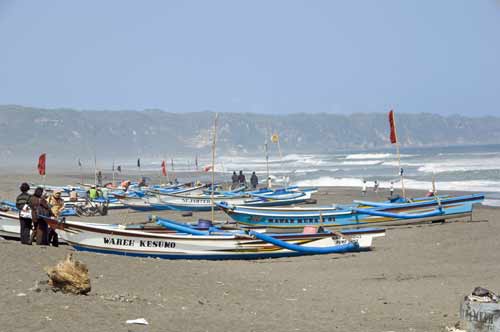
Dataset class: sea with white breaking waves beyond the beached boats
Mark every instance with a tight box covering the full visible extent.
[125,144,500,206]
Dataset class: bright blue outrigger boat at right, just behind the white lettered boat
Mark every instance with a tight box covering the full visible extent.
[217,194,484,229]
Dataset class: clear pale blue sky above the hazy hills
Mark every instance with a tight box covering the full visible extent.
[0,0,500,115]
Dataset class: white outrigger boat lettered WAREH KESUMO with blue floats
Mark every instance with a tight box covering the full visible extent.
[47,218,385,260]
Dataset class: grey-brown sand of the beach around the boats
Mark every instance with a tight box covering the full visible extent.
[0,173,500,332]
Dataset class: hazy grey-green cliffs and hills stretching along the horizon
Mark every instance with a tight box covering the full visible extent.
[0,106,500,162]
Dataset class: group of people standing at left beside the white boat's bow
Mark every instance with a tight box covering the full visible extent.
[16,183,64,246]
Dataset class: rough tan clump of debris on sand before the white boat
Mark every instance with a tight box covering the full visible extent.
[46,253,91,295]
